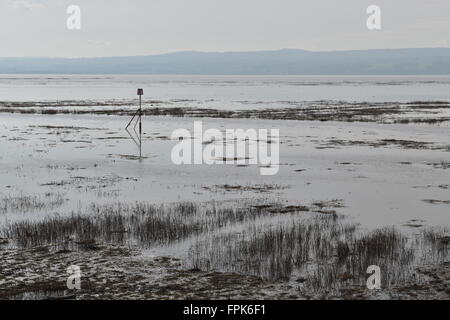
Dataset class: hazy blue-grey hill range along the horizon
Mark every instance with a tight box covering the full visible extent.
[0,48,450,75]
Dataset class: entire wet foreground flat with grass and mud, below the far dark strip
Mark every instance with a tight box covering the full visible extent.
[0,109,450,299]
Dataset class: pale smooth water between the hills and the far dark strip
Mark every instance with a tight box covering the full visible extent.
[0,74,450,103]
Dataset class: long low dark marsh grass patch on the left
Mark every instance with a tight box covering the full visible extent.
[0,202,276,249]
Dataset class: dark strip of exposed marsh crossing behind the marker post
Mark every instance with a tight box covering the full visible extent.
[0,100,450,124]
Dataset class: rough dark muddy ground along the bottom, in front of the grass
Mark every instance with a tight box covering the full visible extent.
[0,246,450,300]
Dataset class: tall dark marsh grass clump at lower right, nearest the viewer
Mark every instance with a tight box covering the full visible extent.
[185,213,450,292]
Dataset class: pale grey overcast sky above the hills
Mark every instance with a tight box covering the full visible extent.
[0,0,450,57]
